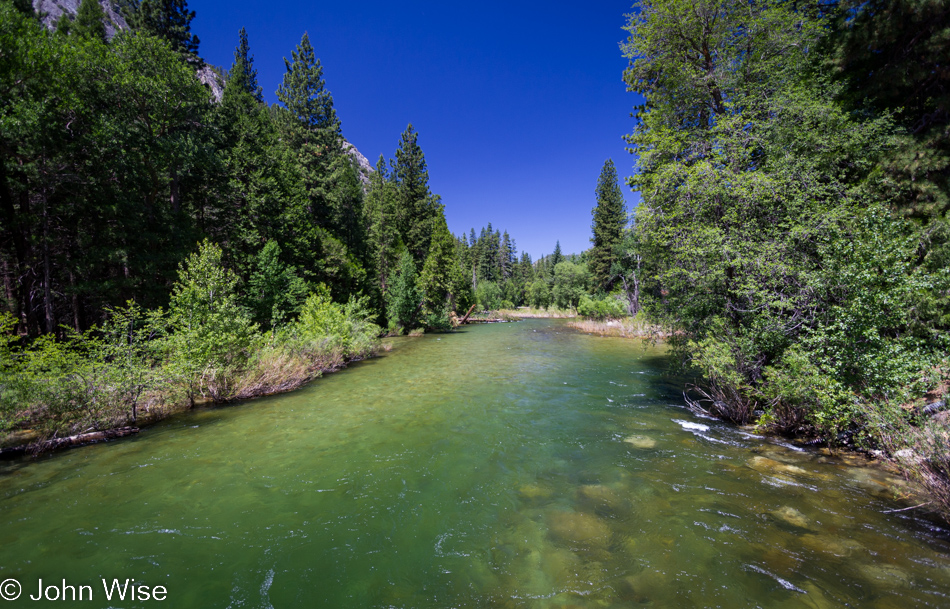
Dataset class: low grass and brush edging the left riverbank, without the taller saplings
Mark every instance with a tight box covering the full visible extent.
[0,303,380,452]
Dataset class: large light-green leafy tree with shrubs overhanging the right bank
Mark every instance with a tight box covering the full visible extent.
[618,0,947,433]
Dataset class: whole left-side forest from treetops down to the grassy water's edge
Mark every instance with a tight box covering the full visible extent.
[0,0,626,446]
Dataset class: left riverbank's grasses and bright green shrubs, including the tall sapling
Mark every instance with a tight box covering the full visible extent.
[0,240,381,451]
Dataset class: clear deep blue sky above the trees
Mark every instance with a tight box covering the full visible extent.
[189,0,638,259]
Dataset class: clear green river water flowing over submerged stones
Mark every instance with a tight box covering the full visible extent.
[0,320,950,609]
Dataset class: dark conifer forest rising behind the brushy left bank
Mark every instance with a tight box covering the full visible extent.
[0,0,640,337]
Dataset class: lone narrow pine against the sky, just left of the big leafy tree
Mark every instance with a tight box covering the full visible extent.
[589,159,627,291]
